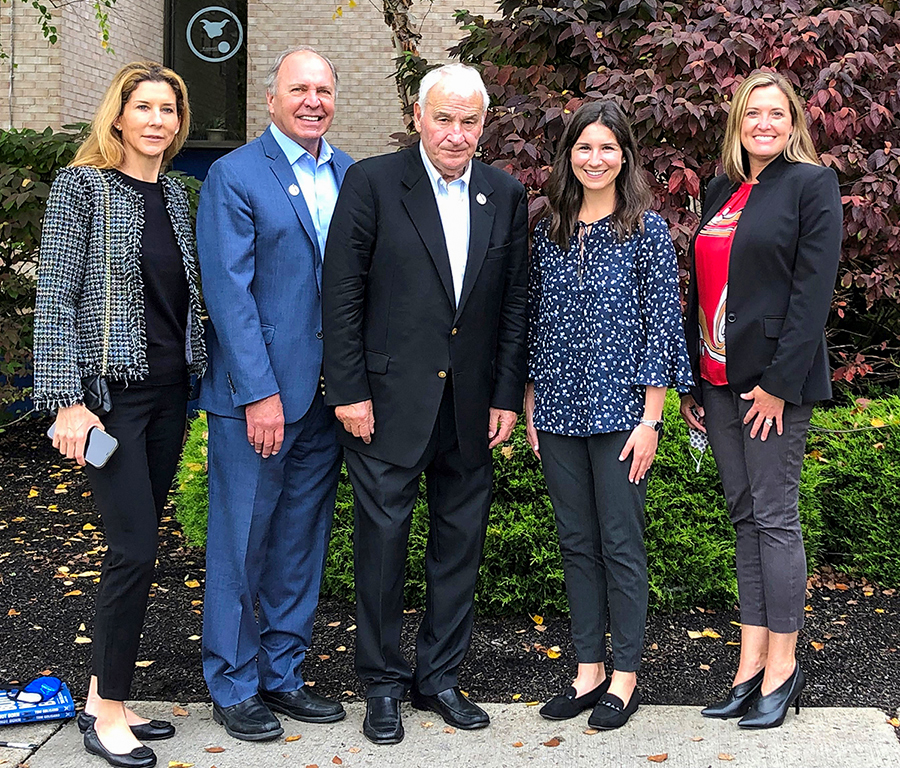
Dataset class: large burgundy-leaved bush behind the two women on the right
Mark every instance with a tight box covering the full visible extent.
[452,0,900,390]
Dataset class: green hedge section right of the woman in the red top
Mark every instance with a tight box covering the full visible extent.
[807,395,900,586]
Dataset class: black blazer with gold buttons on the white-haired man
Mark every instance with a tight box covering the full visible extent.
[322,145,528,467]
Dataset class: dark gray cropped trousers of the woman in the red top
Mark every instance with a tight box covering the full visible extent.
[703,382,812,633]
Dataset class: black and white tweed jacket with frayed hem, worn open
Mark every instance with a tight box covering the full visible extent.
[33,166,206,409]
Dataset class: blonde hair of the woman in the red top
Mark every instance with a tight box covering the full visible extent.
[722,72,819,184]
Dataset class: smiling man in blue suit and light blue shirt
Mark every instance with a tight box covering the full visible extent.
[197,47,353,741]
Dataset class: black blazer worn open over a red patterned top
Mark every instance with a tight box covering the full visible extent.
[685,155,843,405]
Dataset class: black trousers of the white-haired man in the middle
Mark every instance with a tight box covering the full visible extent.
[344,384,492,698]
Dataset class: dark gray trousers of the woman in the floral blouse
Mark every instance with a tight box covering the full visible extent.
[539,432,649,672]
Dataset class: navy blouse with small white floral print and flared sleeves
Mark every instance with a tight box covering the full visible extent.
[528,211,693,437]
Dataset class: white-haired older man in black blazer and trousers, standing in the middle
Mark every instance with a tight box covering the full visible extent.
[323,64,528,744]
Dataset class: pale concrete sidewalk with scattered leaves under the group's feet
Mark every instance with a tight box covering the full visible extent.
[0,702,900,768]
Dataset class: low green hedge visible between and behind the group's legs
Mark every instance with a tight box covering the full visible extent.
[176,395,900,614]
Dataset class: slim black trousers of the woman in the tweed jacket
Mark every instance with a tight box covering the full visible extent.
[85,382,188,701]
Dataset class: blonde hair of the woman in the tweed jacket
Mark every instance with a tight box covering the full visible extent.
[69,61,191,168]
